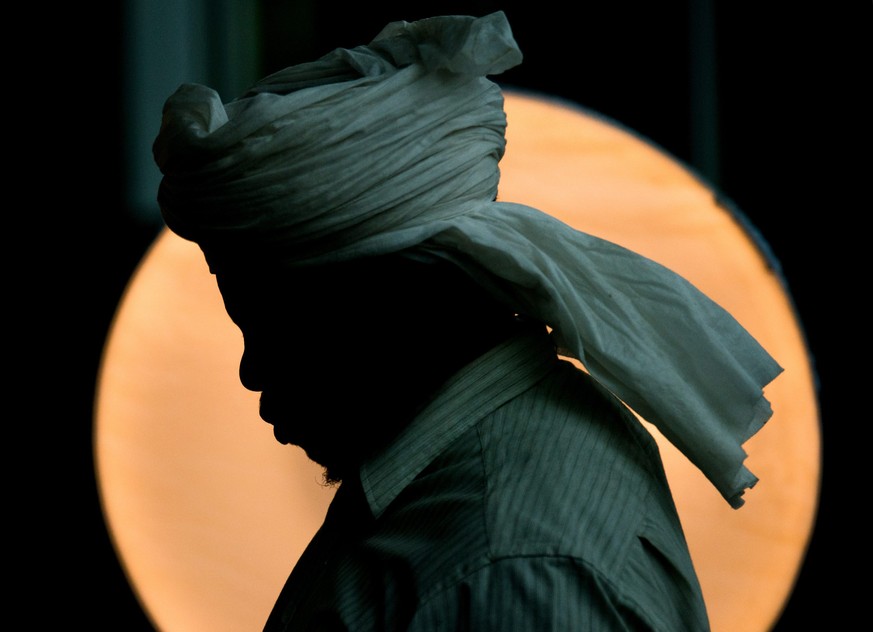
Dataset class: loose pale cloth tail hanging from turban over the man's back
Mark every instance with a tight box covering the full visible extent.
[428,202,782,508]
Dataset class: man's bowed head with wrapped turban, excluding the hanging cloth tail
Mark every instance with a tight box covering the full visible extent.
[153,12,523,476]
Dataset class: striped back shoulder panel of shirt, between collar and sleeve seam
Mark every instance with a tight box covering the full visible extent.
[479,362,669,564]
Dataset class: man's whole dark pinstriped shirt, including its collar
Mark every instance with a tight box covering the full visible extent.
[265,329,709,632]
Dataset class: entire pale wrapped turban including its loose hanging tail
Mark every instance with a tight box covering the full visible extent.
[154,12,782,507]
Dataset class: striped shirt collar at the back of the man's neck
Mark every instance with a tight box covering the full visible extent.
[361,326,557,518]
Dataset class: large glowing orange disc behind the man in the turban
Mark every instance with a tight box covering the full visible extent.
[94,93,820,632]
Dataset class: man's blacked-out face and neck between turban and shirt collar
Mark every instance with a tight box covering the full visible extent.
[217,249,532,480]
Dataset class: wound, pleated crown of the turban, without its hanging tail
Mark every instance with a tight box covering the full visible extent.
[154,13,521,270]
